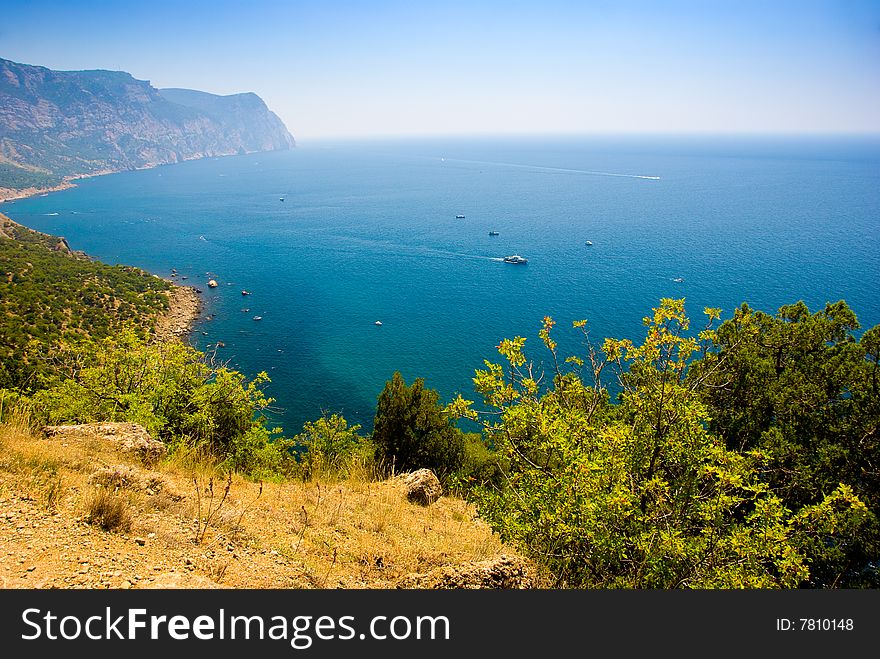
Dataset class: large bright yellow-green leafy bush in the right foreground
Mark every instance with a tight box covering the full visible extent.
[449,299,870,588]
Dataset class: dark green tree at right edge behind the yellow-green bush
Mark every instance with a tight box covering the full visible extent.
[691,301,880,587]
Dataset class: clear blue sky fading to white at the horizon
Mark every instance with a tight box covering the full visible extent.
[0,0,880,141]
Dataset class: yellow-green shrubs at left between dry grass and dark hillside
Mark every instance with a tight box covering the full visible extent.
[31,330,286,475]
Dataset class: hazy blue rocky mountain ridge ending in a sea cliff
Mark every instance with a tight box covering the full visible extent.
[0,58,295,199]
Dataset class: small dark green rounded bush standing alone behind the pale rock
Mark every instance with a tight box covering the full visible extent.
[372,372,464,480]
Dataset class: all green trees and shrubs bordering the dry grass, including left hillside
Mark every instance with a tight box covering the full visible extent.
[0,215,880,589]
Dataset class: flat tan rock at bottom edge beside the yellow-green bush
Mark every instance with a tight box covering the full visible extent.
[396,556,535,590]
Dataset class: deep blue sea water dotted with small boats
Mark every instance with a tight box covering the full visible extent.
[6,137,880,433]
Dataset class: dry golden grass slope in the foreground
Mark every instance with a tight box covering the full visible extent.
[0,419,515,588]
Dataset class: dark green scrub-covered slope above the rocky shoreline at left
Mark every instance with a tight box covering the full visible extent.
[0,215,171,393]
